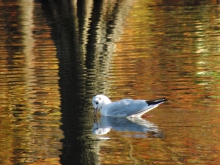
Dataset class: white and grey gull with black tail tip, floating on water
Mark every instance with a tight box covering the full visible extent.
[92,94,167,118]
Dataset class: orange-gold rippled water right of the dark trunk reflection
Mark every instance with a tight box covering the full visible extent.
[100,0,220,164]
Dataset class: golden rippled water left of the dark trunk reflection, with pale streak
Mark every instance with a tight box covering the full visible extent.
[0,1,62,164]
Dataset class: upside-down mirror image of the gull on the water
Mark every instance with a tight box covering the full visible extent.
[92,116,163,139]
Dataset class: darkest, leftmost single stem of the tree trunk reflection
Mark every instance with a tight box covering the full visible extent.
[40,2,96,164]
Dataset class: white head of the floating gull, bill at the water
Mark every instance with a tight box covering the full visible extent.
[92,95,111,114]
